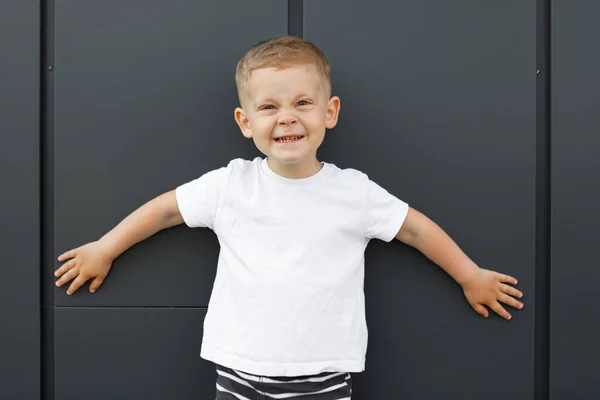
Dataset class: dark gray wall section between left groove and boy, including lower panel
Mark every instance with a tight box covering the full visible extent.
[51,0,287,400]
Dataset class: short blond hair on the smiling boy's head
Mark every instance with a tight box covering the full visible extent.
[235,36,331,104]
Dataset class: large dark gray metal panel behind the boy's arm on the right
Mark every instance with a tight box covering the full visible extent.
[304,0,536,400]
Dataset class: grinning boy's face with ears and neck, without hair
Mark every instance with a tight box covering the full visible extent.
[235,64,340,177]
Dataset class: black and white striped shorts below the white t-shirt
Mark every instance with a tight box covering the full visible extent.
[216,364,352,400]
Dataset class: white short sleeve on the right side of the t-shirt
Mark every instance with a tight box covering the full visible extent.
[366,180,409,242]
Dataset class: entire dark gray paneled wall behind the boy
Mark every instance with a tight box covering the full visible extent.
[0,0,600,400]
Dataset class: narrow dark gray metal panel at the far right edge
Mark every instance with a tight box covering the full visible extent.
[550,0,600,400]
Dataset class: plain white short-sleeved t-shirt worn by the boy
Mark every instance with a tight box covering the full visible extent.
[176,158,408,376]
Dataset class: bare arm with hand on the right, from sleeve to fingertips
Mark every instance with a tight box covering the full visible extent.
[396,208,523,319]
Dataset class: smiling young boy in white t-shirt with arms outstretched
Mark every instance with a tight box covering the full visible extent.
[55,37,523,400]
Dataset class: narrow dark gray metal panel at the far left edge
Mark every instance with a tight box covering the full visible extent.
[0,0,40,399]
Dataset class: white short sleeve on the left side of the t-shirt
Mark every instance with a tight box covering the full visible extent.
[175,167,230,229]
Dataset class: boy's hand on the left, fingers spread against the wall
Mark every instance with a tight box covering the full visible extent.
[54,241,114,295]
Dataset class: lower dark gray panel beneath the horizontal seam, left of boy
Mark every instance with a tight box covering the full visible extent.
[55,307,211,400]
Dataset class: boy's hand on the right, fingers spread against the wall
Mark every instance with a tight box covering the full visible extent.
[462,268,523,320]
